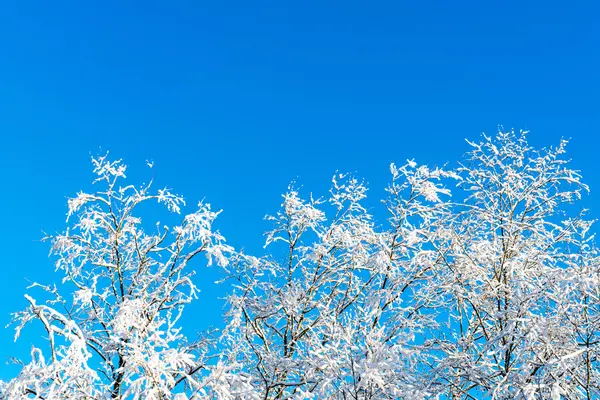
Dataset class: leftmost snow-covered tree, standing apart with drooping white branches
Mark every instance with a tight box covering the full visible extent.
[2,157,230,399]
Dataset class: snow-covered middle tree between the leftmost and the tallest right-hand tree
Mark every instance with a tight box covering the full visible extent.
[218,162,452,399]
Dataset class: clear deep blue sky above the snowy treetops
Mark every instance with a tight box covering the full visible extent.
[0,0,600,378]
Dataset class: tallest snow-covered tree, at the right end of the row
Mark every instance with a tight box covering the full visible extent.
[428,132,600,399]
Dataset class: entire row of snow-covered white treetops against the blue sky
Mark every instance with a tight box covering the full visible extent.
[0,132,600,400]
